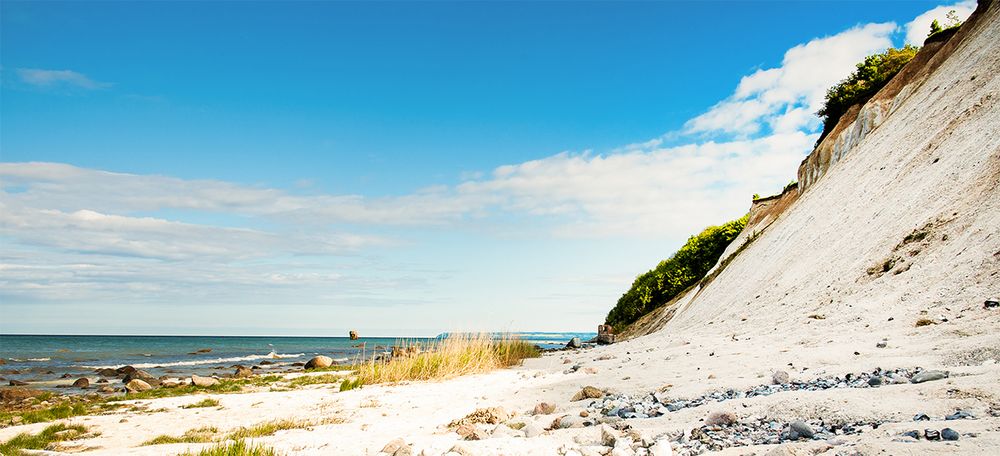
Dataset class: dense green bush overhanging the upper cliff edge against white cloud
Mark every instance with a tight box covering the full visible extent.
[816,44,920,145]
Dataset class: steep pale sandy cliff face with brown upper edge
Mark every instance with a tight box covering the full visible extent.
[627,1,1000,337]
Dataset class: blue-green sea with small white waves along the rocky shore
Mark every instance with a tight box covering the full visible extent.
[0,332,596,388]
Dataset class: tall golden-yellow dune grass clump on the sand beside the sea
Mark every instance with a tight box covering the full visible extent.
[356,334,540,385]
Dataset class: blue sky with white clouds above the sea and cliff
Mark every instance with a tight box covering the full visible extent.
[0,0,975,336]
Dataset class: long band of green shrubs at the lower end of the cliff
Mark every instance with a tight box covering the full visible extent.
[606,216,748,331]
